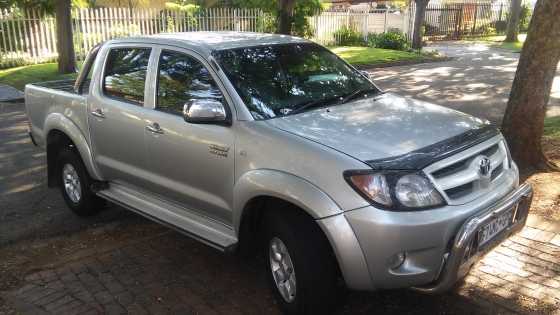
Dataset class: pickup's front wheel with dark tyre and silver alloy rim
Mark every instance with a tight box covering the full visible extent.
[263,209,340,314]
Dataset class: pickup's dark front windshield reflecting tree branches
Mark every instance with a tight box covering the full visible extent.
[214,43,378,119]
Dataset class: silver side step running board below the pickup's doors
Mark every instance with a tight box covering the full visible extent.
[96,183,237,252]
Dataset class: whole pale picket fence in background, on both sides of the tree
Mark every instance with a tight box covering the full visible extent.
[0,8,410,68]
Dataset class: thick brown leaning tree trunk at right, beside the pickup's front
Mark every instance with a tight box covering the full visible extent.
[502,0,560,169]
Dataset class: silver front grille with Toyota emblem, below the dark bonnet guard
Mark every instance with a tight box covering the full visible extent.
[424,136,510,205]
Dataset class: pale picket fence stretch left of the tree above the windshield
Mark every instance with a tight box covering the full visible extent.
[0,8,270,68]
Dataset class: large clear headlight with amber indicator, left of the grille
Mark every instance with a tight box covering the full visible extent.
[344,171,444,210]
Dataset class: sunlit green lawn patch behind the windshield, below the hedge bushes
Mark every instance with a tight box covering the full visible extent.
[331,46,426,65]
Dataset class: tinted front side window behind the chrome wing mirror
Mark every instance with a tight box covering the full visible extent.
[156,51,222,114]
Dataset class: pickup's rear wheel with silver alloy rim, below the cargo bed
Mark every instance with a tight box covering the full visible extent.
[57,148,105,217]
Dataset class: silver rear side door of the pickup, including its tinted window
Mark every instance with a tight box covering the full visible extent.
[88,46,152,187]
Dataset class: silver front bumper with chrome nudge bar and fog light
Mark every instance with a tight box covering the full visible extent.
[326,178,532,293]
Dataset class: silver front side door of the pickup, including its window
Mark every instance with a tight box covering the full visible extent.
[145,49,234,225]
